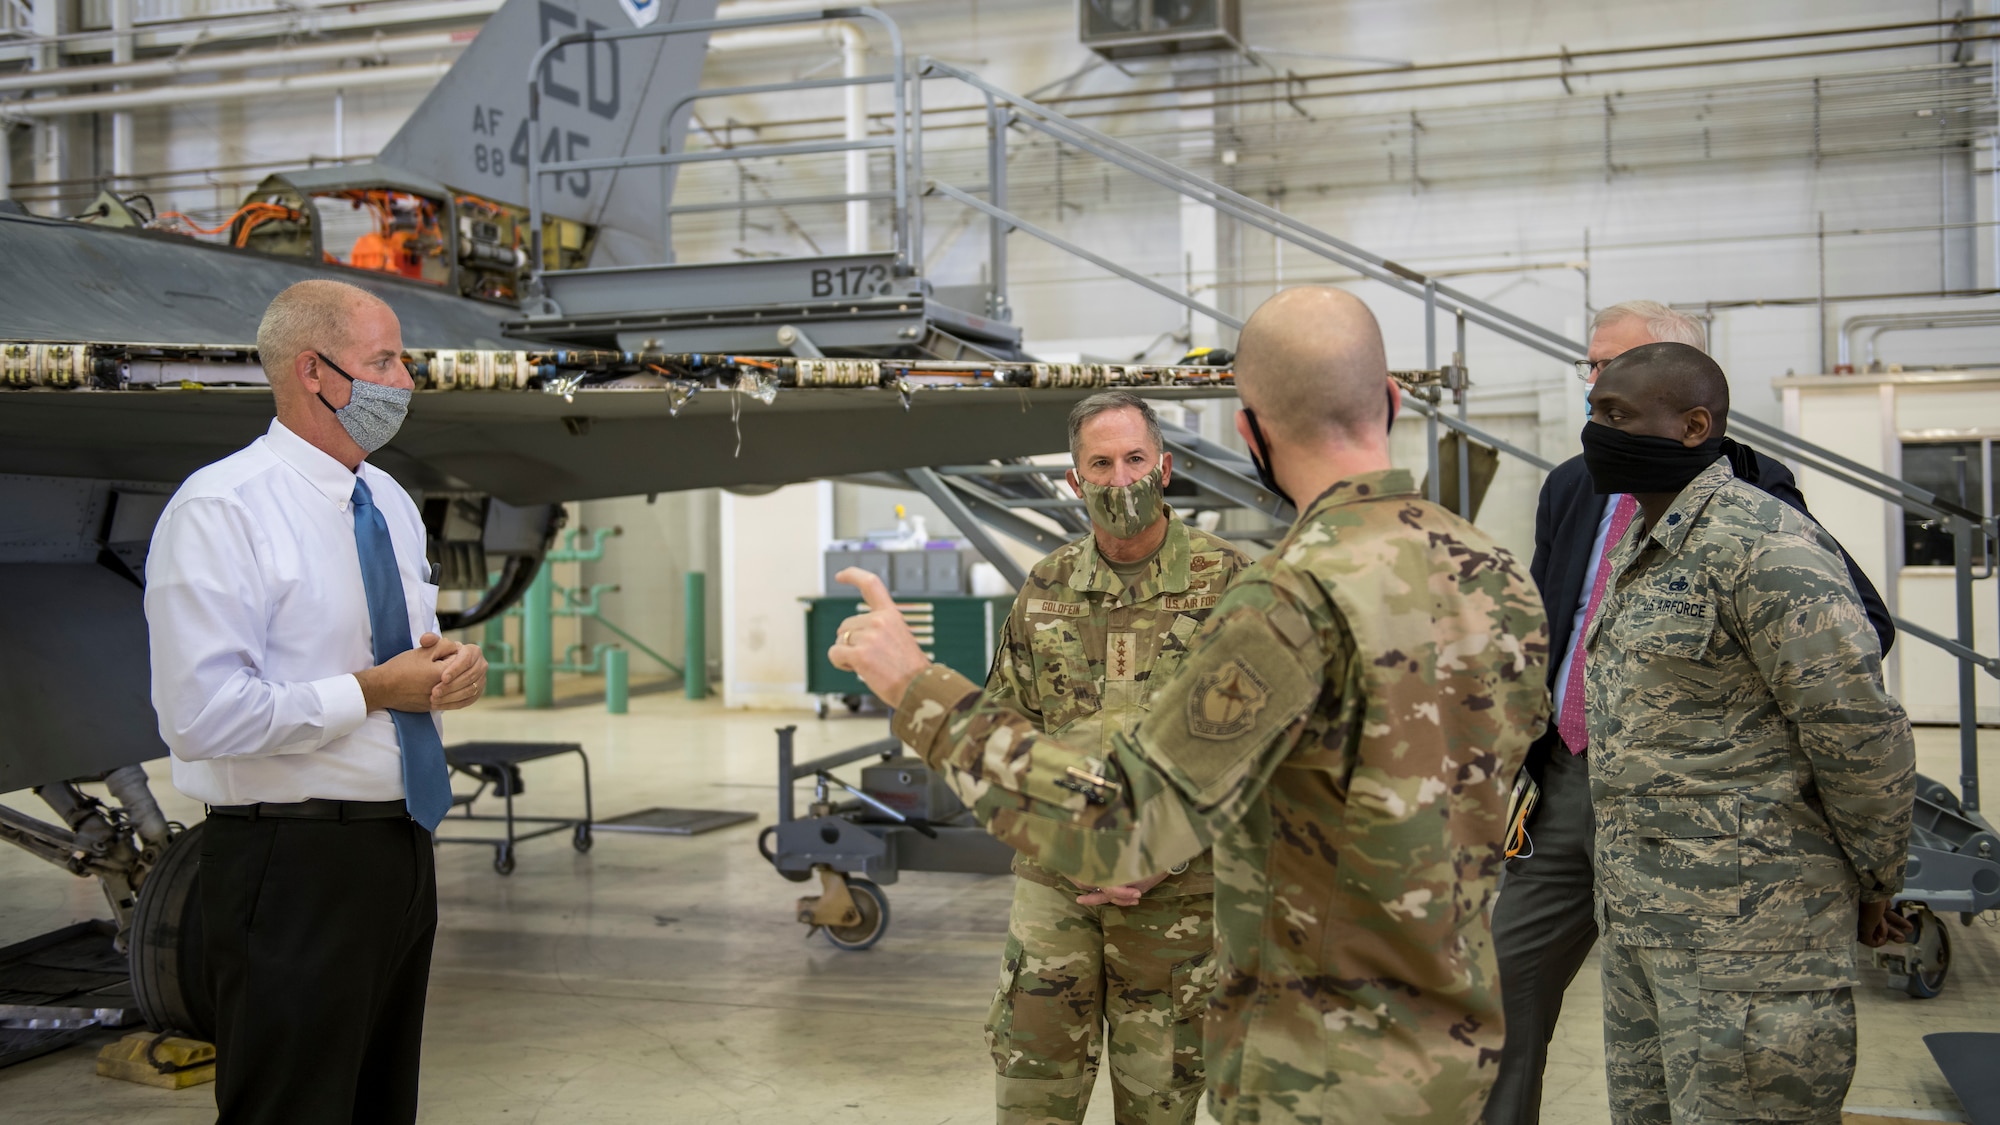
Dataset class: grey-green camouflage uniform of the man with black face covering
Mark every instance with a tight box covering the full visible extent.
[1586,460,1916,1125]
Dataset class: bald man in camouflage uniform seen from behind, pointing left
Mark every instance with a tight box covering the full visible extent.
[830,288,1548,1125]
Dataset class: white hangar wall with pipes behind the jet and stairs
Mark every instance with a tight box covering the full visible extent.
[0,0,2000,700]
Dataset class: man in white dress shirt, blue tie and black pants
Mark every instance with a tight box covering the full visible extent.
[146,280,486,1125]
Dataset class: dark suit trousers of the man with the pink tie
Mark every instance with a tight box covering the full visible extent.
[1484,729,1598,1125]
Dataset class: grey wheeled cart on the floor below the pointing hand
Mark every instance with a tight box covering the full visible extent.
[758,727,1014,949]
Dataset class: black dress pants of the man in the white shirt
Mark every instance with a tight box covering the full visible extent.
[200,815,438,1125]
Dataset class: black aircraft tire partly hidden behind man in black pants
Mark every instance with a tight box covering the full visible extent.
[126,823,216,1039]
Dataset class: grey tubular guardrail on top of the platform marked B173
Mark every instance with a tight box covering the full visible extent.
[528,8,912,290]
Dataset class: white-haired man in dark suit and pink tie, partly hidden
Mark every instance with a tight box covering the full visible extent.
[1484,300,1896,1125]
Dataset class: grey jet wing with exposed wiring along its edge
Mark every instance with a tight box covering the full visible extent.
[0,374,1228,506]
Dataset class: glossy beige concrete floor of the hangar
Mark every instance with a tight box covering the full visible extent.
[0,695,2000,1125]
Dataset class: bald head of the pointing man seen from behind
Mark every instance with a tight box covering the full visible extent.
[1236,286,1388,442]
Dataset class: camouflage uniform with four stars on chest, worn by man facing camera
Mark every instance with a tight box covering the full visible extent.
[986,512,1250,1125]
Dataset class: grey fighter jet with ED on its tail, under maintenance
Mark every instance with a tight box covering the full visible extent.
[0,0,1268,1035]
